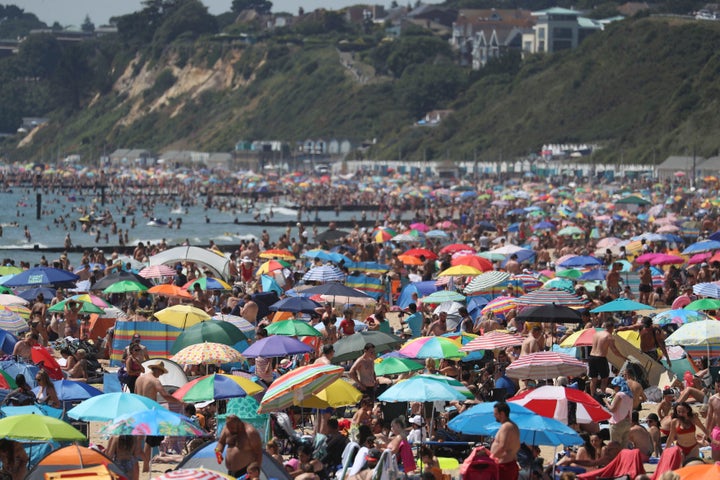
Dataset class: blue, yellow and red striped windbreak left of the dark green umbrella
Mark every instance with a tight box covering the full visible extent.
[110,321,182,367]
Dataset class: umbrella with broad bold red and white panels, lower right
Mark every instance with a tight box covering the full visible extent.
[508,385,611,425]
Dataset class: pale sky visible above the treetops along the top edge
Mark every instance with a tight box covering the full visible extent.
[16,0,439,26]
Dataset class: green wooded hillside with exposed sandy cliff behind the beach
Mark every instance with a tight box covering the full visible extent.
[0,0,720,163]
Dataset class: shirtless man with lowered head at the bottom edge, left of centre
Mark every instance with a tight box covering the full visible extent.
[215,415,263,478]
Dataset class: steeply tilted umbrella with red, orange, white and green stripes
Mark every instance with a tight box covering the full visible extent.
[258,364,345,413]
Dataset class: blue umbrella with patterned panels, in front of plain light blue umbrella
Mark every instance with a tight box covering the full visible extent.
[99,408,207,437]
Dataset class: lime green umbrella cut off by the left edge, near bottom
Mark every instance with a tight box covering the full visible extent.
[0,414,86,442]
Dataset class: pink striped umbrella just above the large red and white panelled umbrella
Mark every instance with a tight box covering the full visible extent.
[505,352,587,380]
